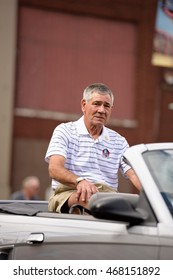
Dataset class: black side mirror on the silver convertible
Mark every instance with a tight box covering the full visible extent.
[89,197,148,225]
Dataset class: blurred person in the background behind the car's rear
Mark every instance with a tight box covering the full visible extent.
[10,176,40,200]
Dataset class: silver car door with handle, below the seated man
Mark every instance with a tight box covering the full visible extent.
[5,218,159,260]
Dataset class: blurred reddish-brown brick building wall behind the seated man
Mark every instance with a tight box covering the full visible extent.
[0,0,173,197]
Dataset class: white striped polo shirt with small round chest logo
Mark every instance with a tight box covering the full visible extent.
[45,117,130,189]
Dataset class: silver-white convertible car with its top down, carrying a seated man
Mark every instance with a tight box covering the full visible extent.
[0,143,173,260]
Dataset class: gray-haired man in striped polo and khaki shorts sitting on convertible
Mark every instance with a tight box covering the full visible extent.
[45,83,140,212]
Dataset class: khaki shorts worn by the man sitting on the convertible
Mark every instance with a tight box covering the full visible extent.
[48,184,117,213]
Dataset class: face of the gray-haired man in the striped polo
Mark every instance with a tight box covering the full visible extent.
[82,92,112,126]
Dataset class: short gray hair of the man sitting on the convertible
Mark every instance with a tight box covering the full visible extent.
[83,83,114,105]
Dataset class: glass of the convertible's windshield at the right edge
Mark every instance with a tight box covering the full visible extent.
[143,150,173,214]
